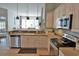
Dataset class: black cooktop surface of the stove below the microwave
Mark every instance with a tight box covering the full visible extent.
[51,35,76,48]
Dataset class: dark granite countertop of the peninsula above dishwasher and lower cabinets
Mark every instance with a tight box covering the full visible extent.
[9,30,48,36]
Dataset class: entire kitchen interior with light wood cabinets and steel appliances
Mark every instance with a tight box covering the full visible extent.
[0,3,79,56]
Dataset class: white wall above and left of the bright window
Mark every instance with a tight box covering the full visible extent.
[0,3,44,29]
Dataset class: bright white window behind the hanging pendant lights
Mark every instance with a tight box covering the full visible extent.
[21,17,40,29]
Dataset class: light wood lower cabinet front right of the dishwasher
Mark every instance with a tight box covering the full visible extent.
[21,36,49,48]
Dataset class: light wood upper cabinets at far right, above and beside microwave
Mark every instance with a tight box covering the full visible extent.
[64,3,79,31]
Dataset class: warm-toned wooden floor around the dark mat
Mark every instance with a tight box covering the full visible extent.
[0,45,49,56]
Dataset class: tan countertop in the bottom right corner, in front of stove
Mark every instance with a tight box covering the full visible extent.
[59,47,79,56]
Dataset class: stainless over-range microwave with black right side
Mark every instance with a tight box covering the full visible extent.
[56,14,73,29]
